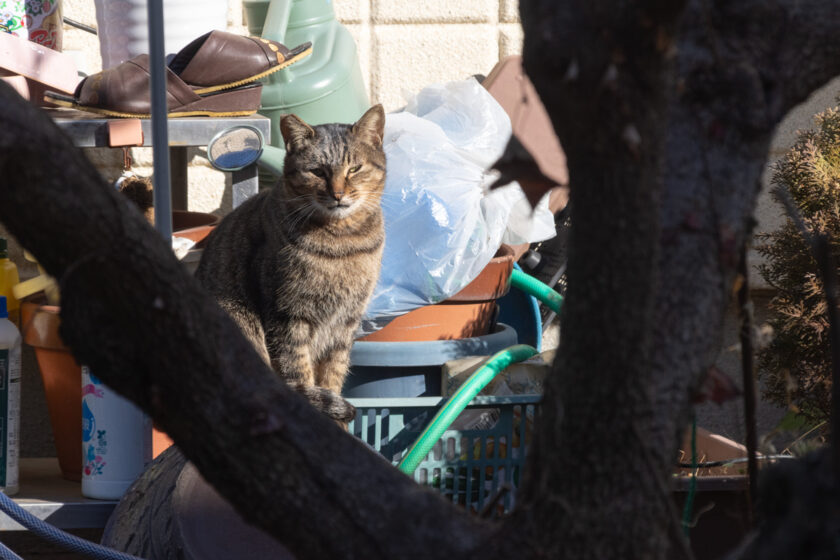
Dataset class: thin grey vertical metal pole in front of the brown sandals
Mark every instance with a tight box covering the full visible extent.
[147,0,172,243]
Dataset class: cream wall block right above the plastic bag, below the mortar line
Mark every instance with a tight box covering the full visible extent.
[372,24,499,111]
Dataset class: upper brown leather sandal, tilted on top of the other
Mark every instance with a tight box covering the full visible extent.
[169,30,312,94]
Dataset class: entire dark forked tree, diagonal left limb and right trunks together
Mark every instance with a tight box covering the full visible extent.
[0,0,840,559]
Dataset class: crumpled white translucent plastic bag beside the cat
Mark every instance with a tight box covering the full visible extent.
[359,79,554,335]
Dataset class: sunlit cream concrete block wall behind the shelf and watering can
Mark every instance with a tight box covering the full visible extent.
[55,0,522,214]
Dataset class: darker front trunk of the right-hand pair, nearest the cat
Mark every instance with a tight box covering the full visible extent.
[514,0,686,558]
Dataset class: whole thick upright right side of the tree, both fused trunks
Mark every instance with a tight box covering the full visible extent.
[516,0,840,558]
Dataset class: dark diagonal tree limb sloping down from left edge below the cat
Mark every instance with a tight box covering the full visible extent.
[0,84,492,559]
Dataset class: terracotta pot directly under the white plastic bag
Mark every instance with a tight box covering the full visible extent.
[359,245,514,342]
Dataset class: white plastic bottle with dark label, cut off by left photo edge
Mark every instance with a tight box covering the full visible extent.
[0,296,20,496]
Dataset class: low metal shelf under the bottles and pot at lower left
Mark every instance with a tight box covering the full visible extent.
[0,457,117,531]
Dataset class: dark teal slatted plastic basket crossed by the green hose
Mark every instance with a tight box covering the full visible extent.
[348,395,541,512]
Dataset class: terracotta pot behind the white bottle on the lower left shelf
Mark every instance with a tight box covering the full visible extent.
[21,296,172,481]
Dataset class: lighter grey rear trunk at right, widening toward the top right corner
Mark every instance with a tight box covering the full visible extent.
[652,0,840,482]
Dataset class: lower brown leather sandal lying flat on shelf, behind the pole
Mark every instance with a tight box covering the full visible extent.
[44,54,262,118]
